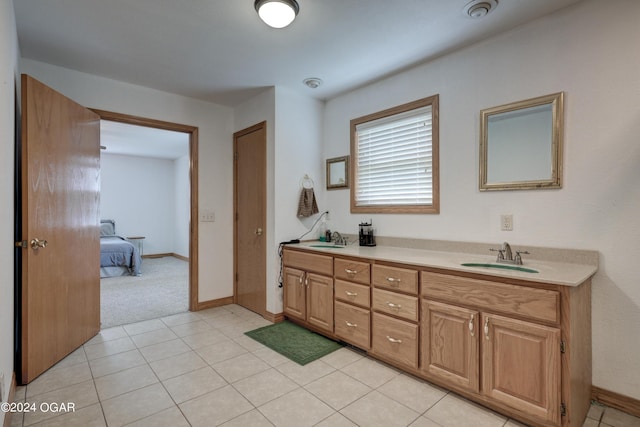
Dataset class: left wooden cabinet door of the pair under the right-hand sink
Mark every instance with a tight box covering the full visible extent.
[421,300,481,392]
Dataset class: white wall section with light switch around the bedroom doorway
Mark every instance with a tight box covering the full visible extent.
[20,59,234,301]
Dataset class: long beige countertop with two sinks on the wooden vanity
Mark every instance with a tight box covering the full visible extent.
[287,241,598,286]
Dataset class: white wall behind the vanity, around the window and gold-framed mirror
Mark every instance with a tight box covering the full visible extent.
[324,0,640,399]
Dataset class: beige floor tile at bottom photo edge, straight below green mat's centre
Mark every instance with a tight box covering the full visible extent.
[258,389,335,427]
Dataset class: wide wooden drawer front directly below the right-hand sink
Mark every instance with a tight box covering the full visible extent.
[421,271,560,323]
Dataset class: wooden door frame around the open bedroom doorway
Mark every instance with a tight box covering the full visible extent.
[90,108,199,311]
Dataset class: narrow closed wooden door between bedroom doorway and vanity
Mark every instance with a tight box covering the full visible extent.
[233,122,267,315]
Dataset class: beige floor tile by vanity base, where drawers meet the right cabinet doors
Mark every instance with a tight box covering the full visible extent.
[377,374,447,414]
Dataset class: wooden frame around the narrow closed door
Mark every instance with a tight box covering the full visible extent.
[233,120,269,318]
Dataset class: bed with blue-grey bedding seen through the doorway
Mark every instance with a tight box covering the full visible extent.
[100,219,142,278]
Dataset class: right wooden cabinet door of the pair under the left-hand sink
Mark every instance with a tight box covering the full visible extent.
[305,273,333,333]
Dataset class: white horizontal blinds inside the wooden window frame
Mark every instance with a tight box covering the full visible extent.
[355,105,433,206]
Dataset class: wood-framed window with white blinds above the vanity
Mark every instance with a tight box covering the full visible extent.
[351,95,439,213]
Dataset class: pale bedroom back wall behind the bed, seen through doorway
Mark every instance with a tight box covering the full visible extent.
[100,152,178,255]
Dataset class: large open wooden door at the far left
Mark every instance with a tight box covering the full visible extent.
[19,75,100,384]
